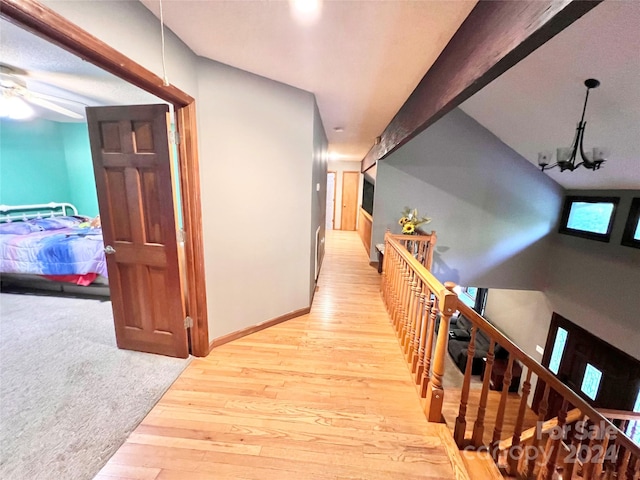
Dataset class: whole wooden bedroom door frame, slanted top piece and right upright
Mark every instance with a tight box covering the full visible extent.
[0,0,209,357]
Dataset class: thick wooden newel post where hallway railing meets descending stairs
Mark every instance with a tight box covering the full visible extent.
[424,282,458,422]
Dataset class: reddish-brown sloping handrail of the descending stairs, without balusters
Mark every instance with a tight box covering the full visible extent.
[458,301,640,456]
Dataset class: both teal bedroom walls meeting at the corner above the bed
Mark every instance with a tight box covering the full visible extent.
[0,119,98,216]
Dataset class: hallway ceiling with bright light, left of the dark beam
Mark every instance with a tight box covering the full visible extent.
[141,0,476,161]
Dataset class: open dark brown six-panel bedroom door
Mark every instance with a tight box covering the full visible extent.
[87,105,189,358]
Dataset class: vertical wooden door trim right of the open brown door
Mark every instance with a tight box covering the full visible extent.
[176,102,209,357]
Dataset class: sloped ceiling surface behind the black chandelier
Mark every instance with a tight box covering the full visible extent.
[461,1,640,189]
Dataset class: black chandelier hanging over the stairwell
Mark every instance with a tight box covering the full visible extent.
[538,78,605,172]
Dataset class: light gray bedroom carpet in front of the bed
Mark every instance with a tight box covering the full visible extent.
[0,293,188,480]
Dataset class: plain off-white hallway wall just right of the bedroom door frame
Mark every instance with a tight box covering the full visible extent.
[197,58,315,339]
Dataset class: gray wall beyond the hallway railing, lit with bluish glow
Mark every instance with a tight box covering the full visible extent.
[371,109,562,290]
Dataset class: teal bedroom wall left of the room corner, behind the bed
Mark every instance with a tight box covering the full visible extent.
[0,119,71,205]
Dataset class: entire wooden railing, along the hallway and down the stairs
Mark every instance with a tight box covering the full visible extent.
[381,232,640,480]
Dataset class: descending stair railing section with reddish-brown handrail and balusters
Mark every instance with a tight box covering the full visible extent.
[454,301,640,480]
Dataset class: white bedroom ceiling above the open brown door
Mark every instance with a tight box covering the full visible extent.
[0,18,163,122]
